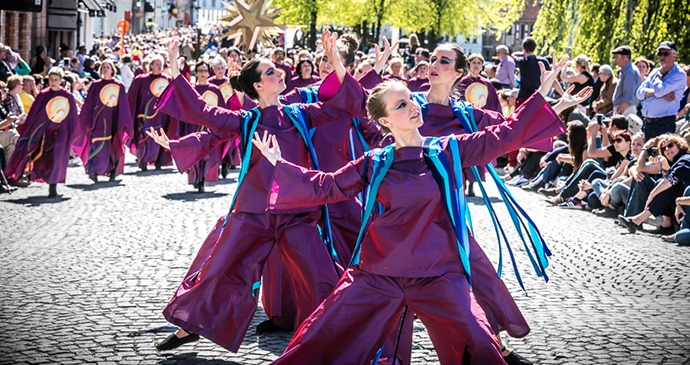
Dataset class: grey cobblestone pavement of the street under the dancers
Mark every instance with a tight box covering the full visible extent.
[0,156,690,364]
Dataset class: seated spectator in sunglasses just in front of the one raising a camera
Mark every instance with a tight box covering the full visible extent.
[559,131,644,210]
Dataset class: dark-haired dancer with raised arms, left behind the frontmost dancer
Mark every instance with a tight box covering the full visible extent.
[146,31,366,352]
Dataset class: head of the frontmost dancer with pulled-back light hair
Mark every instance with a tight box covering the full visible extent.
[378,83,424,136]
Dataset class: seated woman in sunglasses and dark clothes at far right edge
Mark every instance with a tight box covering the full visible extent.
[618,134,690,235]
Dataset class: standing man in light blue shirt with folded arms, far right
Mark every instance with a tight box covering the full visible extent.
[637,41,687,140]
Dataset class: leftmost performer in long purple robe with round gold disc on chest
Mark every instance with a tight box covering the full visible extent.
[5,67,84,198]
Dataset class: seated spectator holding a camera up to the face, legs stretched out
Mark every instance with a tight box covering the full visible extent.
[546,116,629,205]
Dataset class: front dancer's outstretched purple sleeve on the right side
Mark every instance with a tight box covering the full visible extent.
[457,93,566,166]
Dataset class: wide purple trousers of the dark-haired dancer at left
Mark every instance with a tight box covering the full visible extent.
[163,212,338,352]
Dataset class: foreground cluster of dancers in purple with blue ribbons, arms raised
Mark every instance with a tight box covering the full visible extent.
[142,31,591,364]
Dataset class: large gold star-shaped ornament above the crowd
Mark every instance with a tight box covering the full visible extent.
[220,0,281,51]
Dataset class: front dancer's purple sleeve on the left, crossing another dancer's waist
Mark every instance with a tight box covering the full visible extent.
[268,155,366,210]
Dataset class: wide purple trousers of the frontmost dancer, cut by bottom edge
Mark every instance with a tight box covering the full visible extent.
[273,267,505,365]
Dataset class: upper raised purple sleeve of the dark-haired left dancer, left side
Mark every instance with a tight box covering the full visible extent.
[156,75,241,133]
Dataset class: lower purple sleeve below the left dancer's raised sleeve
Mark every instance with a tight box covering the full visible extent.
[170,131,235,173]
